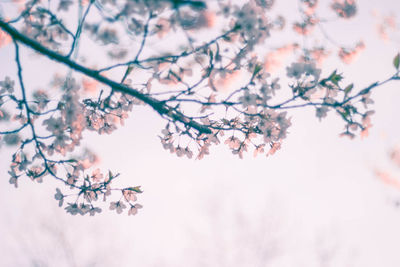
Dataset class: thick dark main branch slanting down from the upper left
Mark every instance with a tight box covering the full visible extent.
[0,19,212,134]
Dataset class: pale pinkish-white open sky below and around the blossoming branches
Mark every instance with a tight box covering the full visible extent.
[0,1,400,267]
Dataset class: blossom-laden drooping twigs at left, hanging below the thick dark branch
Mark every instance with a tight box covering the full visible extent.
[0,76,142,216]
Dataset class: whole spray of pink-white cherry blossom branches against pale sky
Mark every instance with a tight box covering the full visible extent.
[0,0,400,215]
